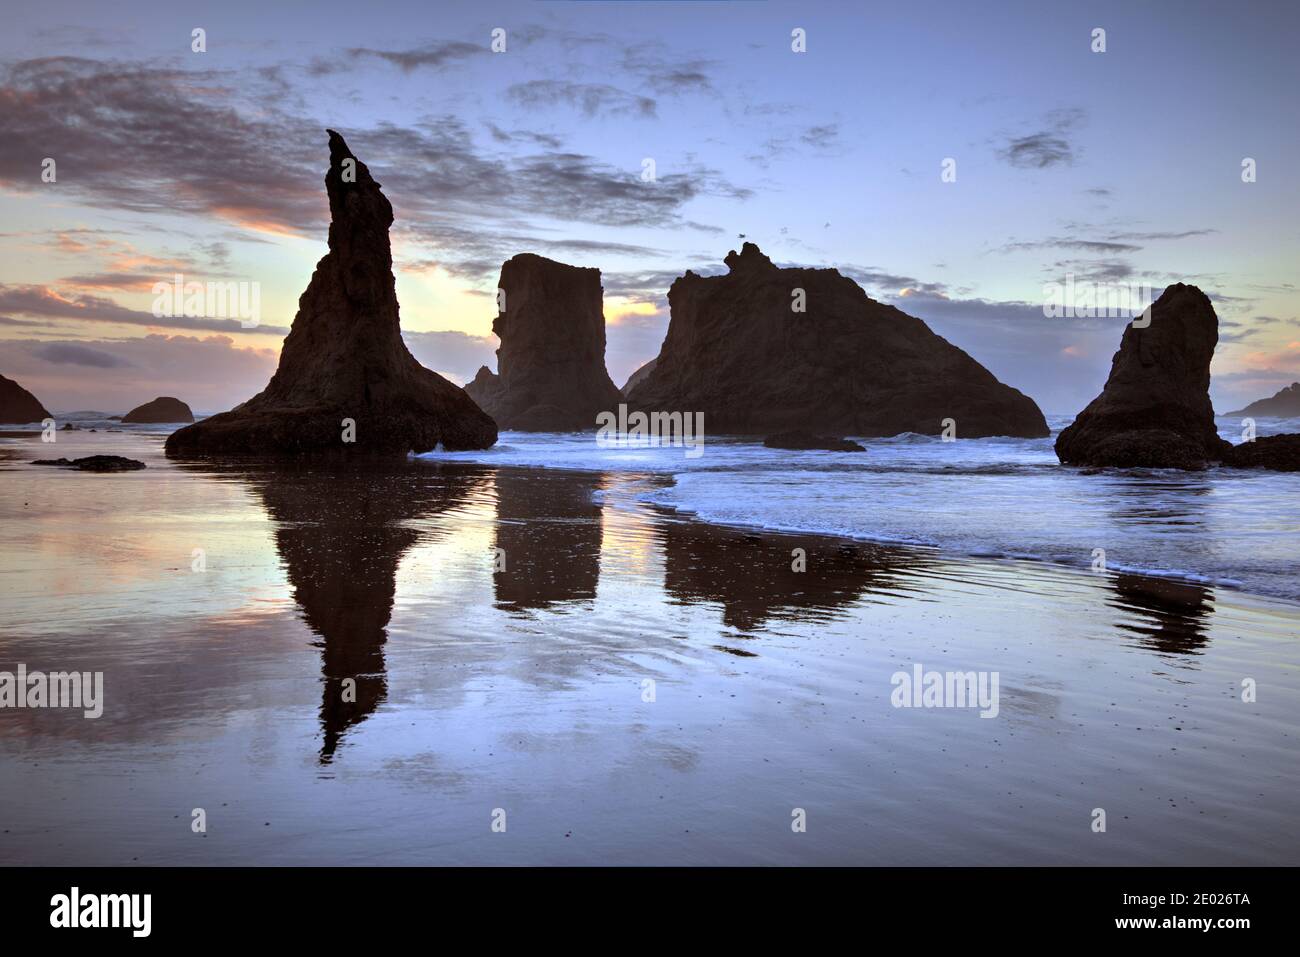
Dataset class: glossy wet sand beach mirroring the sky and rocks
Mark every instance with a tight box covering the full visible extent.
[0,434,1300,865]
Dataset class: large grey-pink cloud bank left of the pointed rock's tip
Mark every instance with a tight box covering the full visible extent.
[0,57,324,228]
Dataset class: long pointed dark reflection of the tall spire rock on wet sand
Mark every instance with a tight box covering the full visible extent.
[233,465,477,763]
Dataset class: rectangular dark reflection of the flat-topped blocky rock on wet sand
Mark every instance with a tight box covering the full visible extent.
[493,469,605,612]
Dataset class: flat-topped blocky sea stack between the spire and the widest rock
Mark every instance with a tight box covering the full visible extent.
[465,252,623,432]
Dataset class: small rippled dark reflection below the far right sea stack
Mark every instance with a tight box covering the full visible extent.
[1109,575,1214,654]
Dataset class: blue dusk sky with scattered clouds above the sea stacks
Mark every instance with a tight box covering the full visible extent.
[0,0,1300,413]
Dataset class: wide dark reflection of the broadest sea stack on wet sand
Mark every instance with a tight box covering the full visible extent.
[660,520,930,631]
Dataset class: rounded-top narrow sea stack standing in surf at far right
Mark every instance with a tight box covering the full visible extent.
[1056,282,1231,468]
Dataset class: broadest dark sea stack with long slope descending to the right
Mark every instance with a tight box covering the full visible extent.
[618,243,1050,438]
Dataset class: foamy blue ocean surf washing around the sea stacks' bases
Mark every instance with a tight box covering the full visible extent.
[423,416,1300,599]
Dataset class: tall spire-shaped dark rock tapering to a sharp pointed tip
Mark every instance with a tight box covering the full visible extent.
[166,130,497,456]
